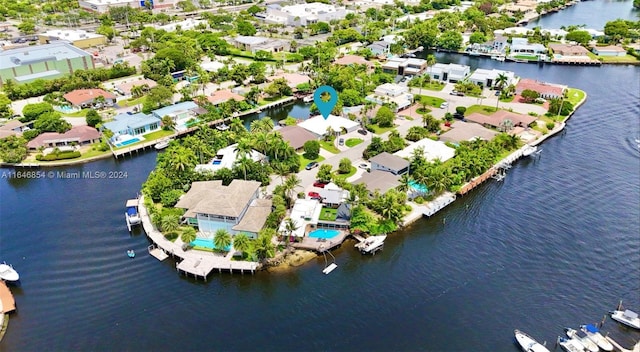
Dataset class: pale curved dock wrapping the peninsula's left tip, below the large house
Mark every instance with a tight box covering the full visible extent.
[138,197,260,281]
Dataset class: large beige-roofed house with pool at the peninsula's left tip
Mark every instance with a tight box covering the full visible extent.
[175,180,271,238]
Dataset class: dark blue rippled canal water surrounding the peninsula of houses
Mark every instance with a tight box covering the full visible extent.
[0,4,640,351]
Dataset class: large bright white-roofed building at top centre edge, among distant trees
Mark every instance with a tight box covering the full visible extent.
[265,2,347,26]
